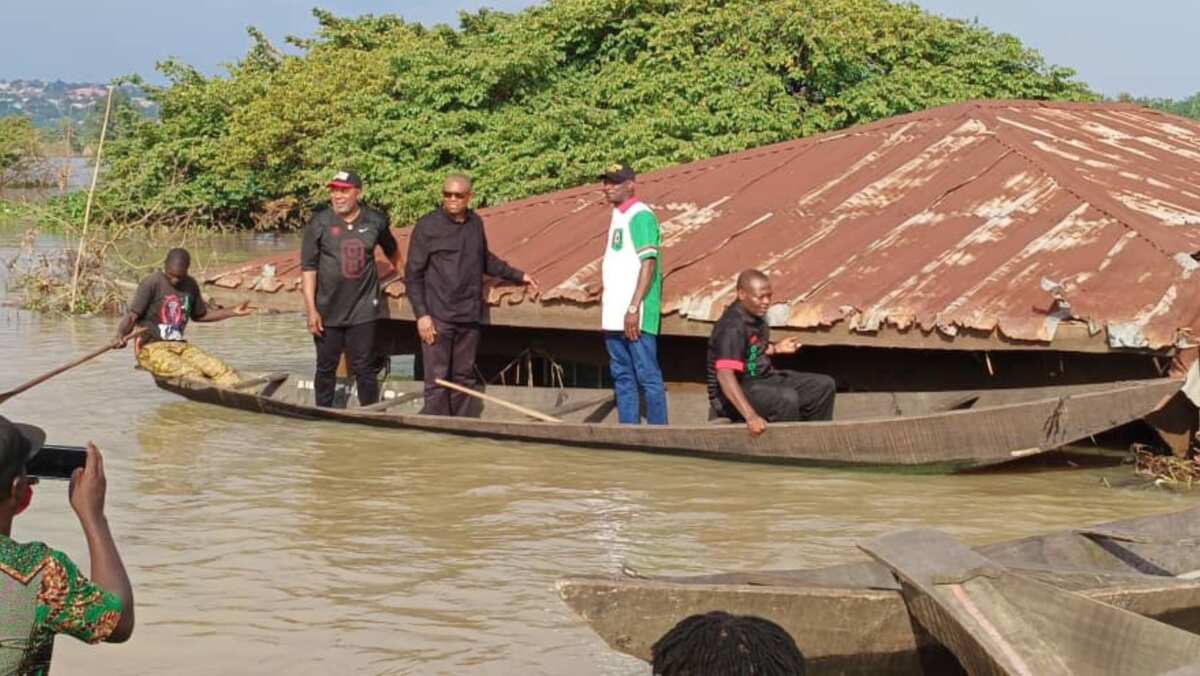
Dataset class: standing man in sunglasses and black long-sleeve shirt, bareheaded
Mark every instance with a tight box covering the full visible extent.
[404,174,538,415]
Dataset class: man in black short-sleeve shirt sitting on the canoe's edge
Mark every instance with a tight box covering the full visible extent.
[707,270,836,437]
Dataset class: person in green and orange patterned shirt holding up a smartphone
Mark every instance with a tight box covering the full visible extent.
[0,417,133,674]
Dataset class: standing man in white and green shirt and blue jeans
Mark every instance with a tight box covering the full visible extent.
[600,164,667,425]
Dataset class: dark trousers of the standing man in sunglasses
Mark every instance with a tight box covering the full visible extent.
[421,319,479,415]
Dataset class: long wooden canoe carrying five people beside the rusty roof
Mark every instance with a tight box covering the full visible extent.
[156,375,1181,472]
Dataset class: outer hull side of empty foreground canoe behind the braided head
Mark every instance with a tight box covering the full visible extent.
[558,578,1200,675]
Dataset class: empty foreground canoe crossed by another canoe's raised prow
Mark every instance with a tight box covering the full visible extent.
[558,507,1200,675]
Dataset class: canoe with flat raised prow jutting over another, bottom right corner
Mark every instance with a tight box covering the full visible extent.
[859,528,1200,676]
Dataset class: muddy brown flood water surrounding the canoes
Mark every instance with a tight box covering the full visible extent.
[0,219,1193,675]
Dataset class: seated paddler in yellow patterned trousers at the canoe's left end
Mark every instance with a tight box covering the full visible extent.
[114,249,251,387]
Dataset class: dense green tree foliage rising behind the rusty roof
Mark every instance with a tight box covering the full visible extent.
[88,0,1093,227]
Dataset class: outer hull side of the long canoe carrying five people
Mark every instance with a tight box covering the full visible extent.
[156,378,1180,472]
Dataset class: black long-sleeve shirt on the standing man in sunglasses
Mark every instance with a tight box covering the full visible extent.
[404,209,524,323]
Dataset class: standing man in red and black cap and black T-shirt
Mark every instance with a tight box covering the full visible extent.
[300,172,400,407]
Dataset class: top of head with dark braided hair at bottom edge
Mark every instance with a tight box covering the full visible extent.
[650,610,804,676]
